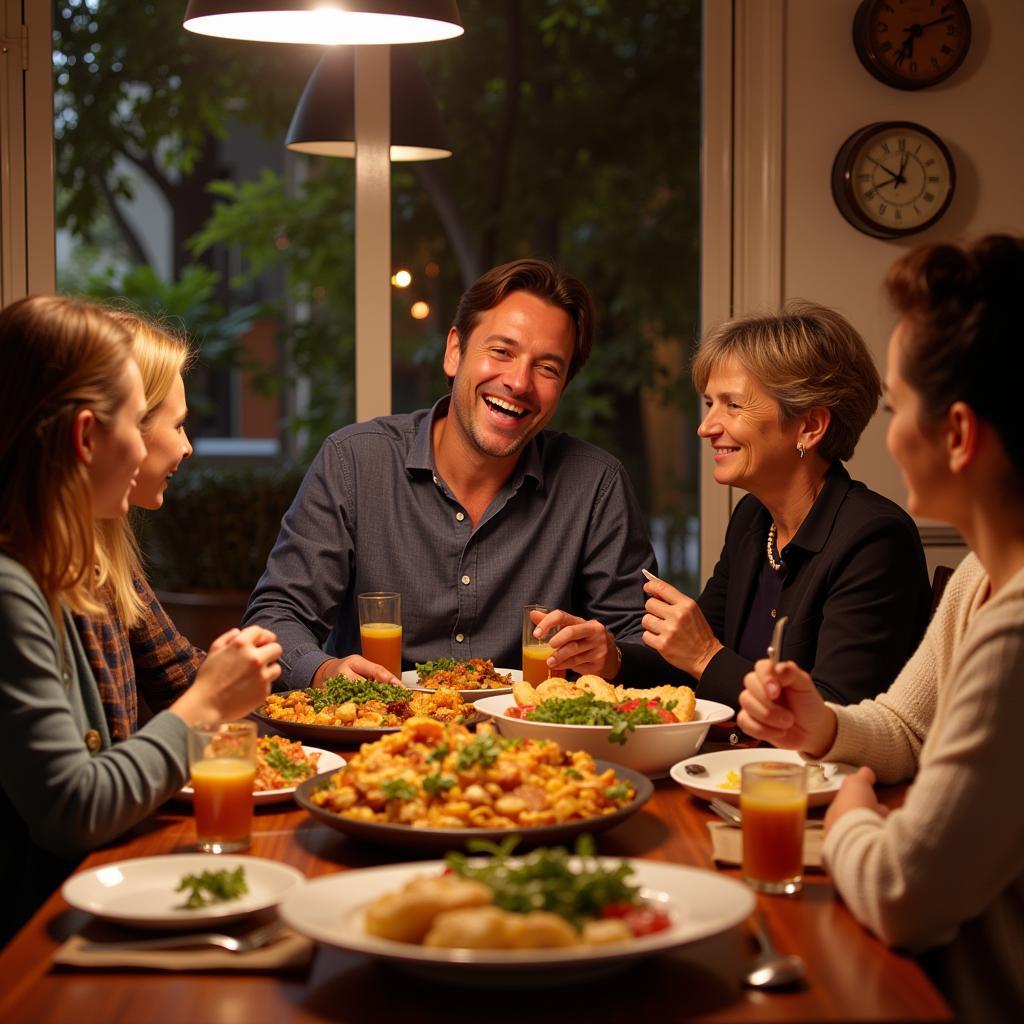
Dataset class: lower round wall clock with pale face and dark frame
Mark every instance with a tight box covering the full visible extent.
[831,121,956,239]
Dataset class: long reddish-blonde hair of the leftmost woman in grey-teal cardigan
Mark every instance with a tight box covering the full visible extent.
[0,295,131,633]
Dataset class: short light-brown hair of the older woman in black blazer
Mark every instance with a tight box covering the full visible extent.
[692,300,882,462]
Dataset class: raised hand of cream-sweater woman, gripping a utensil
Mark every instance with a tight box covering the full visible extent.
[736,658,839,757]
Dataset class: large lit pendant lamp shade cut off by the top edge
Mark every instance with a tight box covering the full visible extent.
[184,0,463,46]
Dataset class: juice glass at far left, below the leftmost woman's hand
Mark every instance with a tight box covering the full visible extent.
[188,722,256,853]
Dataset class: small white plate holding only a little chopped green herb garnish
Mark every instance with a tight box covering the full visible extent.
[60,853,305,931]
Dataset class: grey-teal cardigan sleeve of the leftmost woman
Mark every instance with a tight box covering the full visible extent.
[0,557,187,857]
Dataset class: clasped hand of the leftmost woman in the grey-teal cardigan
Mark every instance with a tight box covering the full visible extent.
[170,626,281,726]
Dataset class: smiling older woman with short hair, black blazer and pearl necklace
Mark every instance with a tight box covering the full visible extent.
[643,302,931,707]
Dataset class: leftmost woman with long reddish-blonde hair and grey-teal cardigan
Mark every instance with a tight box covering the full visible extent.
[0,295,281,941]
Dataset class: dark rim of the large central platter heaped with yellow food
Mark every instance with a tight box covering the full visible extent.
[295,761,654,852]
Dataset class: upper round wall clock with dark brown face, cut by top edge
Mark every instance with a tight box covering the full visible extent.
[853,0,971,89]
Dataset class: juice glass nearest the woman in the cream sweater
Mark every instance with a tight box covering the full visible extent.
[739,761,807,895]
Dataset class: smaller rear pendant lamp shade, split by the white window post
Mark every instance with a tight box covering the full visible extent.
[285,46,452,161]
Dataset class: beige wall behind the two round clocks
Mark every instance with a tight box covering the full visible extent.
[708,0,1024,577]
